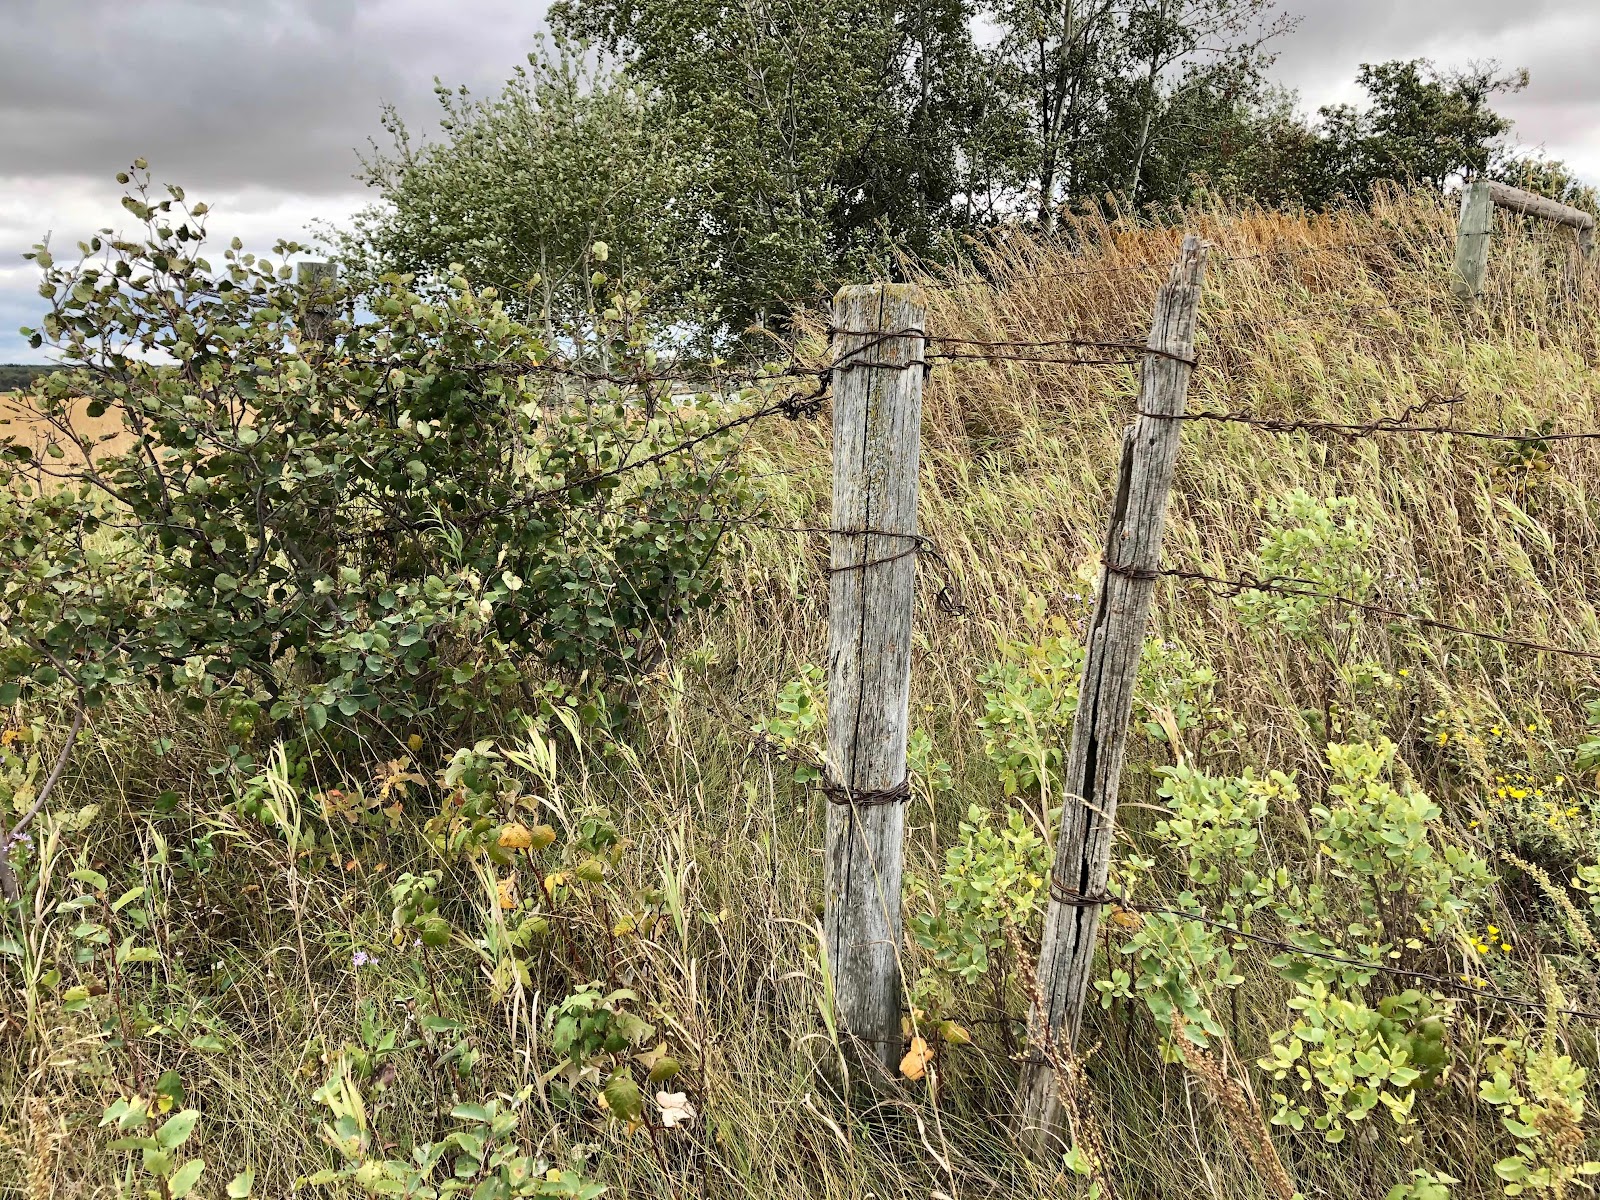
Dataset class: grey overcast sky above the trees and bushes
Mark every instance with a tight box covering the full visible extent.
[0,0,1600,362]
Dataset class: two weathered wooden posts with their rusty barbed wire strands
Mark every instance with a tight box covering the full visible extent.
[318,197,1600,1154]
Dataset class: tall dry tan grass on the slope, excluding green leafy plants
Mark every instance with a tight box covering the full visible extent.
[0,195,1600,1200]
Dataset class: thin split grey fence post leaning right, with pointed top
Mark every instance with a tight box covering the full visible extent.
[1016,237,1206,1160]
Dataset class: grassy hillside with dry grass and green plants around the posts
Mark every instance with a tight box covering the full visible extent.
[0,197,1600,1200]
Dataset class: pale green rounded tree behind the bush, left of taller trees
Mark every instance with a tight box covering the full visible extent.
[341,38,704,339]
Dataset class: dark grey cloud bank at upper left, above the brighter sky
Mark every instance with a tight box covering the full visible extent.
[0,0,541,192]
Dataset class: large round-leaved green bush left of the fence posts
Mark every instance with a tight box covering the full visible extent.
[0,163,744,747]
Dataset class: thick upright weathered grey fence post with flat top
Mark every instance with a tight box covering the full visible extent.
[822,285,926,1070]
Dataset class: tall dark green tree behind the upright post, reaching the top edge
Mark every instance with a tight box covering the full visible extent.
[550,0,989,334]
